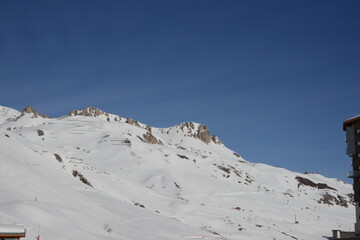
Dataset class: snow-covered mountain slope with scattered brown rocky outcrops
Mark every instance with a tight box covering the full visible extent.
[0,107,355,240]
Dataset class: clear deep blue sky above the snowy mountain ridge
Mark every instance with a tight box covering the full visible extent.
[0,0,360,182]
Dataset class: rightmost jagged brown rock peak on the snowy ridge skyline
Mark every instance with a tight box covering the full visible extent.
[178,122,222,144]
